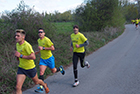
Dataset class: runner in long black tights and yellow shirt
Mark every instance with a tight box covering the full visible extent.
[70,25,90,87]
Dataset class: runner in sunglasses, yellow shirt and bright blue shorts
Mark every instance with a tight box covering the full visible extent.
[35,28,65,93]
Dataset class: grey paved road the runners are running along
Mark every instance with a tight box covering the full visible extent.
[23,24,140,94]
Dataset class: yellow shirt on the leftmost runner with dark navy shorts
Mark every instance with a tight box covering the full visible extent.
[16,41,35,70]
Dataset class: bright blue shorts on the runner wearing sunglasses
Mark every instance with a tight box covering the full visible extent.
[39,56,55,69]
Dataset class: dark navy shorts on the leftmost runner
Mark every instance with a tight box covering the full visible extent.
[17,67,37,78]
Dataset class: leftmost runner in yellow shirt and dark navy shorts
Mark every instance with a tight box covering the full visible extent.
[15,29,49,94]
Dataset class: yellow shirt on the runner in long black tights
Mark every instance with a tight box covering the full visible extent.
[71,32,87,53]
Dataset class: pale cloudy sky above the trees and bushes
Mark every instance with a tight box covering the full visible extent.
[0,0,84,13]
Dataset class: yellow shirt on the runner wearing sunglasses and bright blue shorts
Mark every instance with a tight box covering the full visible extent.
[37,37,53,59]
